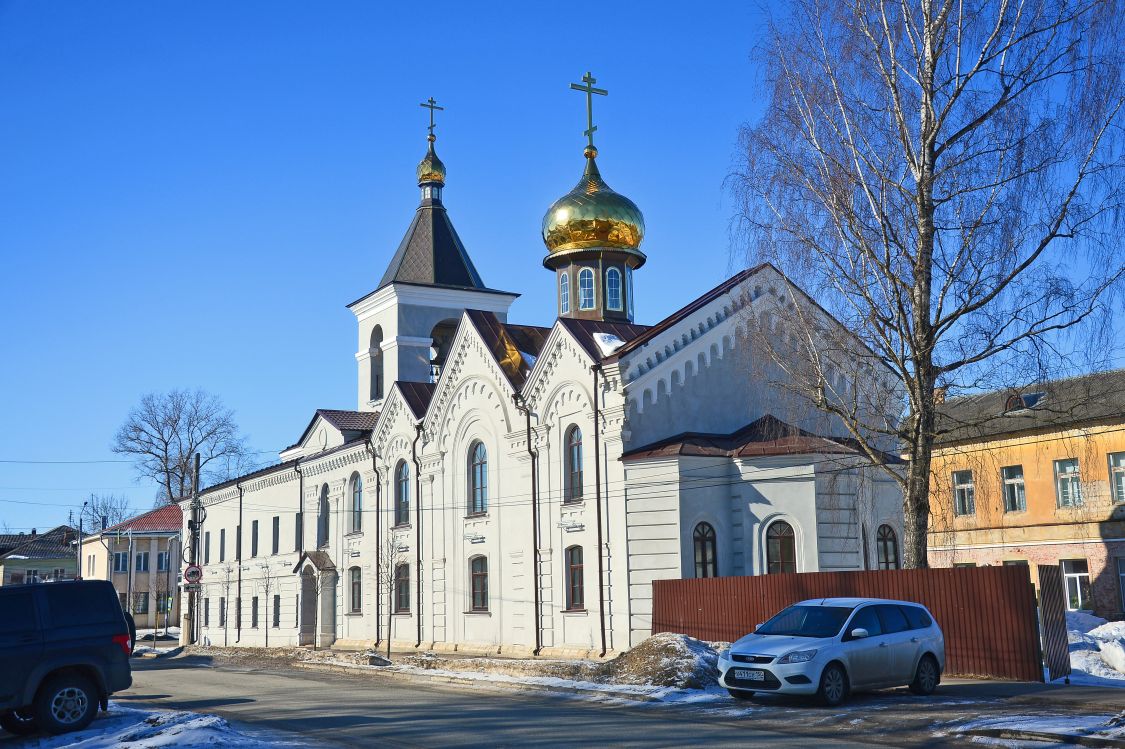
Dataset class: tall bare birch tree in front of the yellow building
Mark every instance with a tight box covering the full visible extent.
[734,0,1125,567]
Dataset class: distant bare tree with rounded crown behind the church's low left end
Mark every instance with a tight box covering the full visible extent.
[113,390,251,506]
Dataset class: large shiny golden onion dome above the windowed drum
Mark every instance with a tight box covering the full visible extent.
[543,146,645,262]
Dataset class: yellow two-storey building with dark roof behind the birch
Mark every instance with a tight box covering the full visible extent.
[929,370,1125,619]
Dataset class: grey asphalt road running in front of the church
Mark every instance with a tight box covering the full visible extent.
[105,656,927,749]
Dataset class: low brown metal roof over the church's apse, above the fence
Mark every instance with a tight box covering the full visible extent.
[621,414,901,463]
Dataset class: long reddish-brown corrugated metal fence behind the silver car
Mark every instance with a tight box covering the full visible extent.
[653,566,1043,682]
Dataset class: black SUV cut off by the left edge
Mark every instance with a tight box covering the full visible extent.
[0,580,133,734]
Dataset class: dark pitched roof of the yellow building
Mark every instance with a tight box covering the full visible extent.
[936,369,1125,444]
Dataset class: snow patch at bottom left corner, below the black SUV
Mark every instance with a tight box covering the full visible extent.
[17,702,306,749]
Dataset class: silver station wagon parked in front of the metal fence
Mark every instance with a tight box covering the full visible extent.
[719,598,945,705]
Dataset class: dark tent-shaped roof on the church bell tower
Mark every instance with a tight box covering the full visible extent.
[379,201,485,289]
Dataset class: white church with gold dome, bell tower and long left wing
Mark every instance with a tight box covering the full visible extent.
[182,100,902,657]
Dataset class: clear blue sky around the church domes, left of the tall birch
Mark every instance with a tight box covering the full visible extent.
[0,0,763,531]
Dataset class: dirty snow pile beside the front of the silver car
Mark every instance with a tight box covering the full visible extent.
[600,632,719,689]
